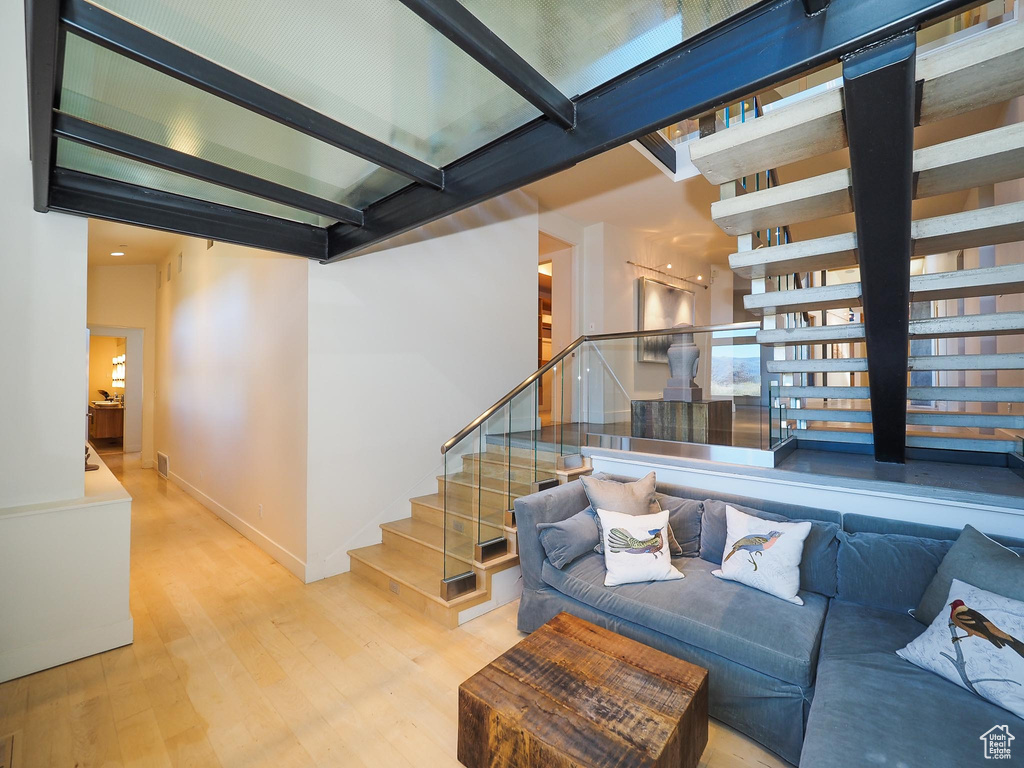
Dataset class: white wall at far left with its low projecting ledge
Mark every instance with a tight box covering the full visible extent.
[0,2,132,682]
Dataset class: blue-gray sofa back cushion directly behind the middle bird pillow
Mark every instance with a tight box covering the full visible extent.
[700,499,840,597]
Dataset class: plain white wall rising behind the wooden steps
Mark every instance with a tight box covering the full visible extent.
[306,193,538,581]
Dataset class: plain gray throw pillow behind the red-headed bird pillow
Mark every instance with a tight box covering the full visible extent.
[913,525,1024,624]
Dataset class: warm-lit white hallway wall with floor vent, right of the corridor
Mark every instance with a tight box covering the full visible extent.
[156,238,307,578]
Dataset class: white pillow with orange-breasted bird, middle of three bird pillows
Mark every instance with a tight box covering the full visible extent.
[712,506,811,605]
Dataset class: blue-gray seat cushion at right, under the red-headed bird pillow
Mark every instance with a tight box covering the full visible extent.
[800,600,1024,768]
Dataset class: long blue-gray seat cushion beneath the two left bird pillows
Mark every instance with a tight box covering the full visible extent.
[541,554,828,687]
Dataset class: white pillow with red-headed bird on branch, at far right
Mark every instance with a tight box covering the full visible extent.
[896,579,1024,718]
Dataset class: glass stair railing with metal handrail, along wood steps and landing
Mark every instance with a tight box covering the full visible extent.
[441,323,790,600]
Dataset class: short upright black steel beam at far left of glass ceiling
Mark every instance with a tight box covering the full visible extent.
[25,0,61,212]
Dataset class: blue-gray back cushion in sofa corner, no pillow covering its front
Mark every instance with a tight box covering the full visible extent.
[837,531,952,618]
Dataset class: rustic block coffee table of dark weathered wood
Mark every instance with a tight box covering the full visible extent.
[459,613,708,768]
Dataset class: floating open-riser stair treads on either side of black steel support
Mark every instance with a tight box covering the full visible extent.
[689,19,1024,453]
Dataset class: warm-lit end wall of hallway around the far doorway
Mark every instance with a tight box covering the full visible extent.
[86,264,157,467]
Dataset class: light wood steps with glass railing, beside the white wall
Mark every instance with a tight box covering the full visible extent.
[348,444,558,628]
